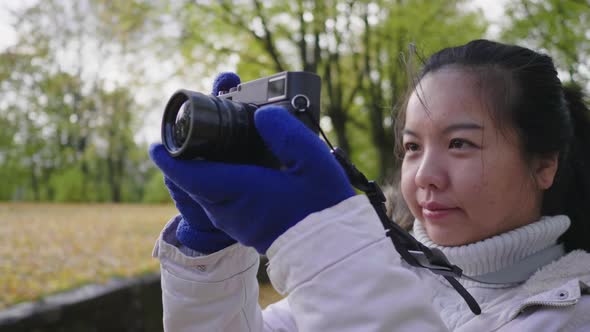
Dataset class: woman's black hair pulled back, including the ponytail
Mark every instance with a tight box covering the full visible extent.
[396,39,590,251]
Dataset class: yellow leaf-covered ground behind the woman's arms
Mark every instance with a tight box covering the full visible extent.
[0,203,280,309]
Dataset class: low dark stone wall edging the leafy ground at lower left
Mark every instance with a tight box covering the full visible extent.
[0,274,162,332]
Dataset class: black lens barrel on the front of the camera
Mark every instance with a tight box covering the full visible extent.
[162,90,264,163]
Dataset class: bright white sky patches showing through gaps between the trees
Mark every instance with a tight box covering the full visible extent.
[0,0,508,142]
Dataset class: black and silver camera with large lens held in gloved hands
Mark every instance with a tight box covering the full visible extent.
[162,71,321,167]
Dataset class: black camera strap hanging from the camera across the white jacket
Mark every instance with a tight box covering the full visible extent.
[299,110,481,315]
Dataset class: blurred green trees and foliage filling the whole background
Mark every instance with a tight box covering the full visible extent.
[0,0,590,203]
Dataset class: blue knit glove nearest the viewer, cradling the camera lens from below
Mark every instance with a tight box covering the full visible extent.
[150,106,355,254]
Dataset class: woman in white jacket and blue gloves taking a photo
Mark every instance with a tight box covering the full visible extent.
[150,40,590,331]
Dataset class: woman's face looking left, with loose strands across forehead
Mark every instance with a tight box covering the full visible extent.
[401,68,552,246]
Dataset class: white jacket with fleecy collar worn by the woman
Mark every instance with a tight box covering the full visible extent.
[154,196,590,332]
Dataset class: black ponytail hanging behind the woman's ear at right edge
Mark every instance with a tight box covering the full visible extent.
[556,85,590,252]
